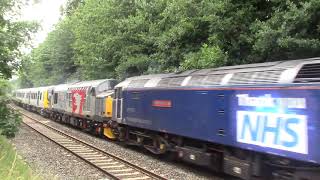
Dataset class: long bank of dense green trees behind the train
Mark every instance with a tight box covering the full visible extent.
[20,0,320,87]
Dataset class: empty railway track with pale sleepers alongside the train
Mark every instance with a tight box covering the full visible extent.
[10,105,165,180]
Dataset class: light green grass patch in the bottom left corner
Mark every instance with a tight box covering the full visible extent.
[0,136,40,180]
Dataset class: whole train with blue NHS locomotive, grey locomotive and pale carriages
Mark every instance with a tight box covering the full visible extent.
[15,58,320,180]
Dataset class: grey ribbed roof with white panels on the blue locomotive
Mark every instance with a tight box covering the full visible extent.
[116,58,320,88]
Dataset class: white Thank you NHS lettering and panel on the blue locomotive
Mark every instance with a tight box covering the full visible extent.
[236,95,308,154]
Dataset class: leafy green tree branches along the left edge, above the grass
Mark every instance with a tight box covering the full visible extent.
[0,0,37,137]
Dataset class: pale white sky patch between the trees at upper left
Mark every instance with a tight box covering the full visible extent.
[21,0,67,47]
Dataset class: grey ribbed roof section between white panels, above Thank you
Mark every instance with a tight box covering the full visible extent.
[228,70,283,84]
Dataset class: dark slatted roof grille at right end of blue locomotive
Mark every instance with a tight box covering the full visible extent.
[294,63,320,83]
